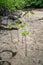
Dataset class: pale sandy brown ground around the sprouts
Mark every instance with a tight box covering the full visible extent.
[0,10,43,65]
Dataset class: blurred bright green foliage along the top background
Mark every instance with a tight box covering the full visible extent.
[0,0,43,12]
